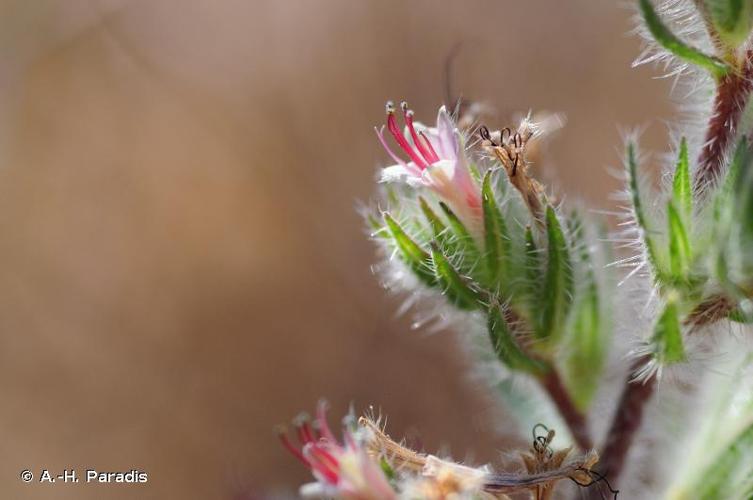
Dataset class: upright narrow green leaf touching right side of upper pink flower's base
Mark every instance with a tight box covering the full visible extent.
[481,170,510,283]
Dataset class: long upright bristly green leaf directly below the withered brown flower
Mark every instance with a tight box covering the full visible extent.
[537,206,573,339]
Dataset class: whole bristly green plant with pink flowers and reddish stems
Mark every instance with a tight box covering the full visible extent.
[284,0,753,499]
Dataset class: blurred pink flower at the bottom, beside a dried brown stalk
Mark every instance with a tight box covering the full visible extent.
[279,402,396,500]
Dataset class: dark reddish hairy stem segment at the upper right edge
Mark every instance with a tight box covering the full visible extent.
[695,51,753,193]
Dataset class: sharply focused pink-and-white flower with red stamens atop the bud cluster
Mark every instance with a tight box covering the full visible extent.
[375,102,481,223]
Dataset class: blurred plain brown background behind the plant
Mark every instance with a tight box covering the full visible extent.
[0,0,672,500]
